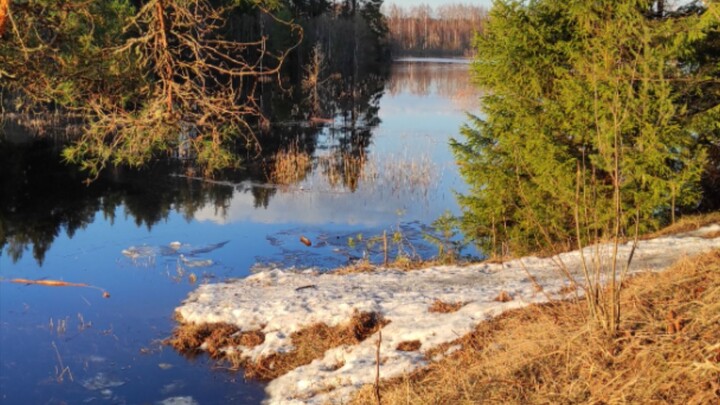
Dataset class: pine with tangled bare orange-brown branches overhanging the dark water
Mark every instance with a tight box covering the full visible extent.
[0,0,302,178]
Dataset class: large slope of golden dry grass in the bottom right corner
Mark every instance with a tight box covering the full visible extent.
[353,251,720,404]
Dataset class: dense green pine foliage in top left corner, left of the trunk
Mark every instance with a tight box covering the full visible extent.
[0,0,134,110]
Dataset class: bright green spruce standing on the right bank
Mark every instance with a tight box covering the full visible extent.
[452,0,720,254]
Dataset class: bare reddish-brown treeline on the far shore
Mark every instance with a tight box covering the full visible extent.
[384,4,487,56]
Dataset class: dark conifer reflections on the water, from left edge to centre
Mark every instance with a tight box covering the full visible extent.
[0,69,385,265]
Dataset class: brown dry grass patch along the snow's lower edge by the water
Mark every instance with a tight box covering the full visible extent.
[165,312,389,380]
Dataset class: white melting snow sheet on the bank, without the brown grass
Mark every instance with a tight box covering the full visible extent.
[177,225,720,404]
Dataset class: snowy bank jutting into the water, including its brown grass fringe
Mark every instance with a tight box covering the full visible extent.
[170,224,720,403]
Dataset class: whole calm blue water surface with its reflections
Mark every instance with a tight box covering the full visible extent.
[0,60,478,404]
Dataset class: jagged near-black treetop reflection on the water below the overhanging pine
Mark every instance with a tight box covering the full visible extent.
[0,137,232,265]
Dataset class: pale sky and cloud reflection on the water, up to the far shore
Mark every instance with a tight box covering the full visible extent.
[195,64,477,227]
